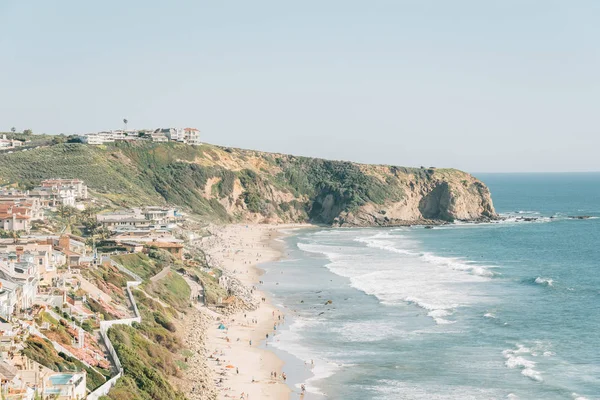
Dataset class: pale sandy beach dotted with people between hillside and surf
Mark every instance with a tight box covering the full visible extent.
[201,225,306,400]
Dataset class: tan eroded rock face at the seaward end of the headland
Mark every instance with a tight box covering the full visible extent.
[184,148,497,227]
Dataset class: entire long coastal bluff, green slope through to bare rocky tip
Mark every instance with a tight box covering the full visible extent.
[0,142,497,227]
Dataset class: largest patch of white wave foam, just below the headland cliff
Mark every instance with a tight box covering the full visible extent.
[298,231,493,325]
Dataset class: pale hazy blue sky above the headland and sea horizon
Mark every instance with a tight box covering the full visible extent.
[0,0,600,172]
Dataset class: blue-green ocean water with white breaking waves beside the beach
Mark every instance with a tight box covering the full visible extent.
[264,174,600,400]
